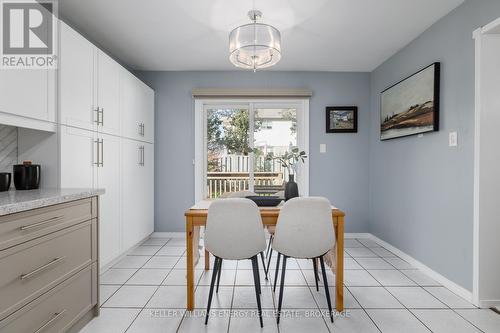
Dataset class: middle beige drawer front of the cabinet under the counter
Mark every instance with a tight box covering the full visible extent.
[0,221,95,319]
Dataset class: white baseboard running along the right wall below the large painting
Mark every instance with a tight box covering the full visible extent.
[370,234,477,305]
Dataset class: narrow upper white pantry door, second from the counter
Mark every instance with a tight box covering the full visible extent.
[96,50,121,135]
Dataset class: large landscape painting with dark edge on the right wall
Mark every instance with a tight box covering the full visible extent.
[380,62,440,140]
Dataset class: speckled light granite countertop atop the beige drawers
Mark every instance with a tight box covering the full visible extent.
[0,188,104,216]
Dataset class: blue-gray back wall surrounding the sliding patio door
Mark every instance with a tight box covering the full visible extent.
[137,71,370,232]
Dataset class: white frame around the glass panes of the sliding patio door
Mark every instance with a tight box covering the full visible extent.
[194,98,310,202]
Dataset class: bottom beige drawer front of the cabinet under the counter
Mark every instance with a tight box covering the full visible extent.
[0,266,96,333]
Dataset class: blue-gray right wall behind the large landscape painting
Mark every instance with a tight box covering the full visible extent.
[369,0,500,290]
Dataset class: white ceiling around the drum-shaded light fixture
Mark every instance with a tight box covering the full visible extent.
[59,0,463,71]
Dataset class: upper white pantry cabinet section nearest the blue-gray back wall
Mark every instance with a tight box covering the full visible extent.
[120,72,154,142]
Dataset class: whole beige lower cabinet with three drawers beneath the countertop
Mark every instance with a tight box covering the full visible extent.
[0,197,99,333]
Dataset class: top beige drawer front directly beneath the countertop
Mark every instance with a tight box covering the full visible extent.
[0,198,95,250]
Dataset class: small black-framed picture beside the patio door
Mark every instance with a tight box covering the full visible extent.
[326,106,358,133]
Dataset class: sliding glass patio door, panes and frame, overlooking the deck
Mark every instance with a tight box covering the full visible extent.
[195,99,309,201]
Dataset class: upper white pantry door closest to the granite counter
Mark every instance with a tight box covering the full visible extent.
[59,22,97,130]
